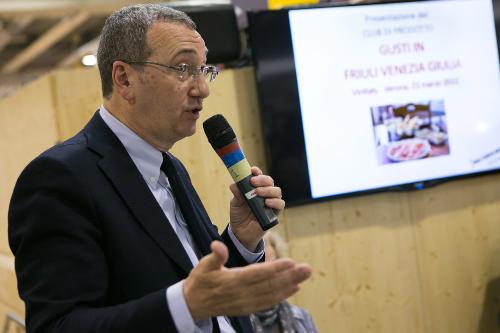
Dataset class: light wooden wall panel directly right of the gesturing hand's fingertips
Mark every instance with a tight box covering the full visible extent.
[284,194,424,332]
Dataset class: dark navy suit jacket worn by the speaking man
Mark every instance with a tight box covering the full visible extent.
[9,113,251,333]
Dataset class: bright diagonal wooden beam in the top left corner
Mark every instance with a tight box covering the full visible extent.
[2,12,90,73]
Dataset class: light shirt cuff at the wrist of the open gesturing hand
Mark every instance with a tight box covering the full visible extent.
[166,280,212,332]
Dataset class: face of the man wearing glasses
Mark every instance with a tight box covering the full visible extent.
[132,22,209,146]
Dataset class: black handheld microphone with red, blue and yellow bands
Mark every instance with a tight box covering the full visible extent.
[203,114,278,230]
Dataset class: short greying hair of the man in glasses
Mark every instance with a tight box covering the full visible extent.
[97,4,196,98]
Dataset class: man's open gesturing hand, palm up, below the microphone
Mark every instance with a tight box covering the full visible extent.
[183,241,311,321]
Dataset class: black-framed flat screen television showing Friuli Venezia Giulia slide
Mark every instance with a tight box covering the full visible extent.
[249,0,500,205]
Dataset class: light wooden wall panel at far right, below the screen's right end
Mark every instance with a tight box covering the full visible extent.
[410,175,500,333]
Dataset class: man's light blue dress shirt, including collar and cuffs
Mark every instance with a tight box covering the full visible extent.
[99,106,264,333]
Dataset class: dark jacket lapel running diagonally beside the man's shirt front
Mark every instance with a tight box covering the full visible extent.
[84,113,193,273]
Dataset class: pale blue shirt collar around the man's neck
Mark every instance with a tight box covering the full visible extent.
[99,105,163,188]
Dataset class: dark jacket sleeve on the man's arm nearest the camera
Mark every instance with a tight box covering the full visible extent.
[8,156,176,333]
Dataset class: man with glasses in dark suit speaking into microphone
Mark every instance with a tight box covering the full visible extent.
[9,5,310,333]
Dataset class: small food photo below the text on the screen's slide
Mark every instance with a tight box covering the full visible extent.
[371,100,450,164]
